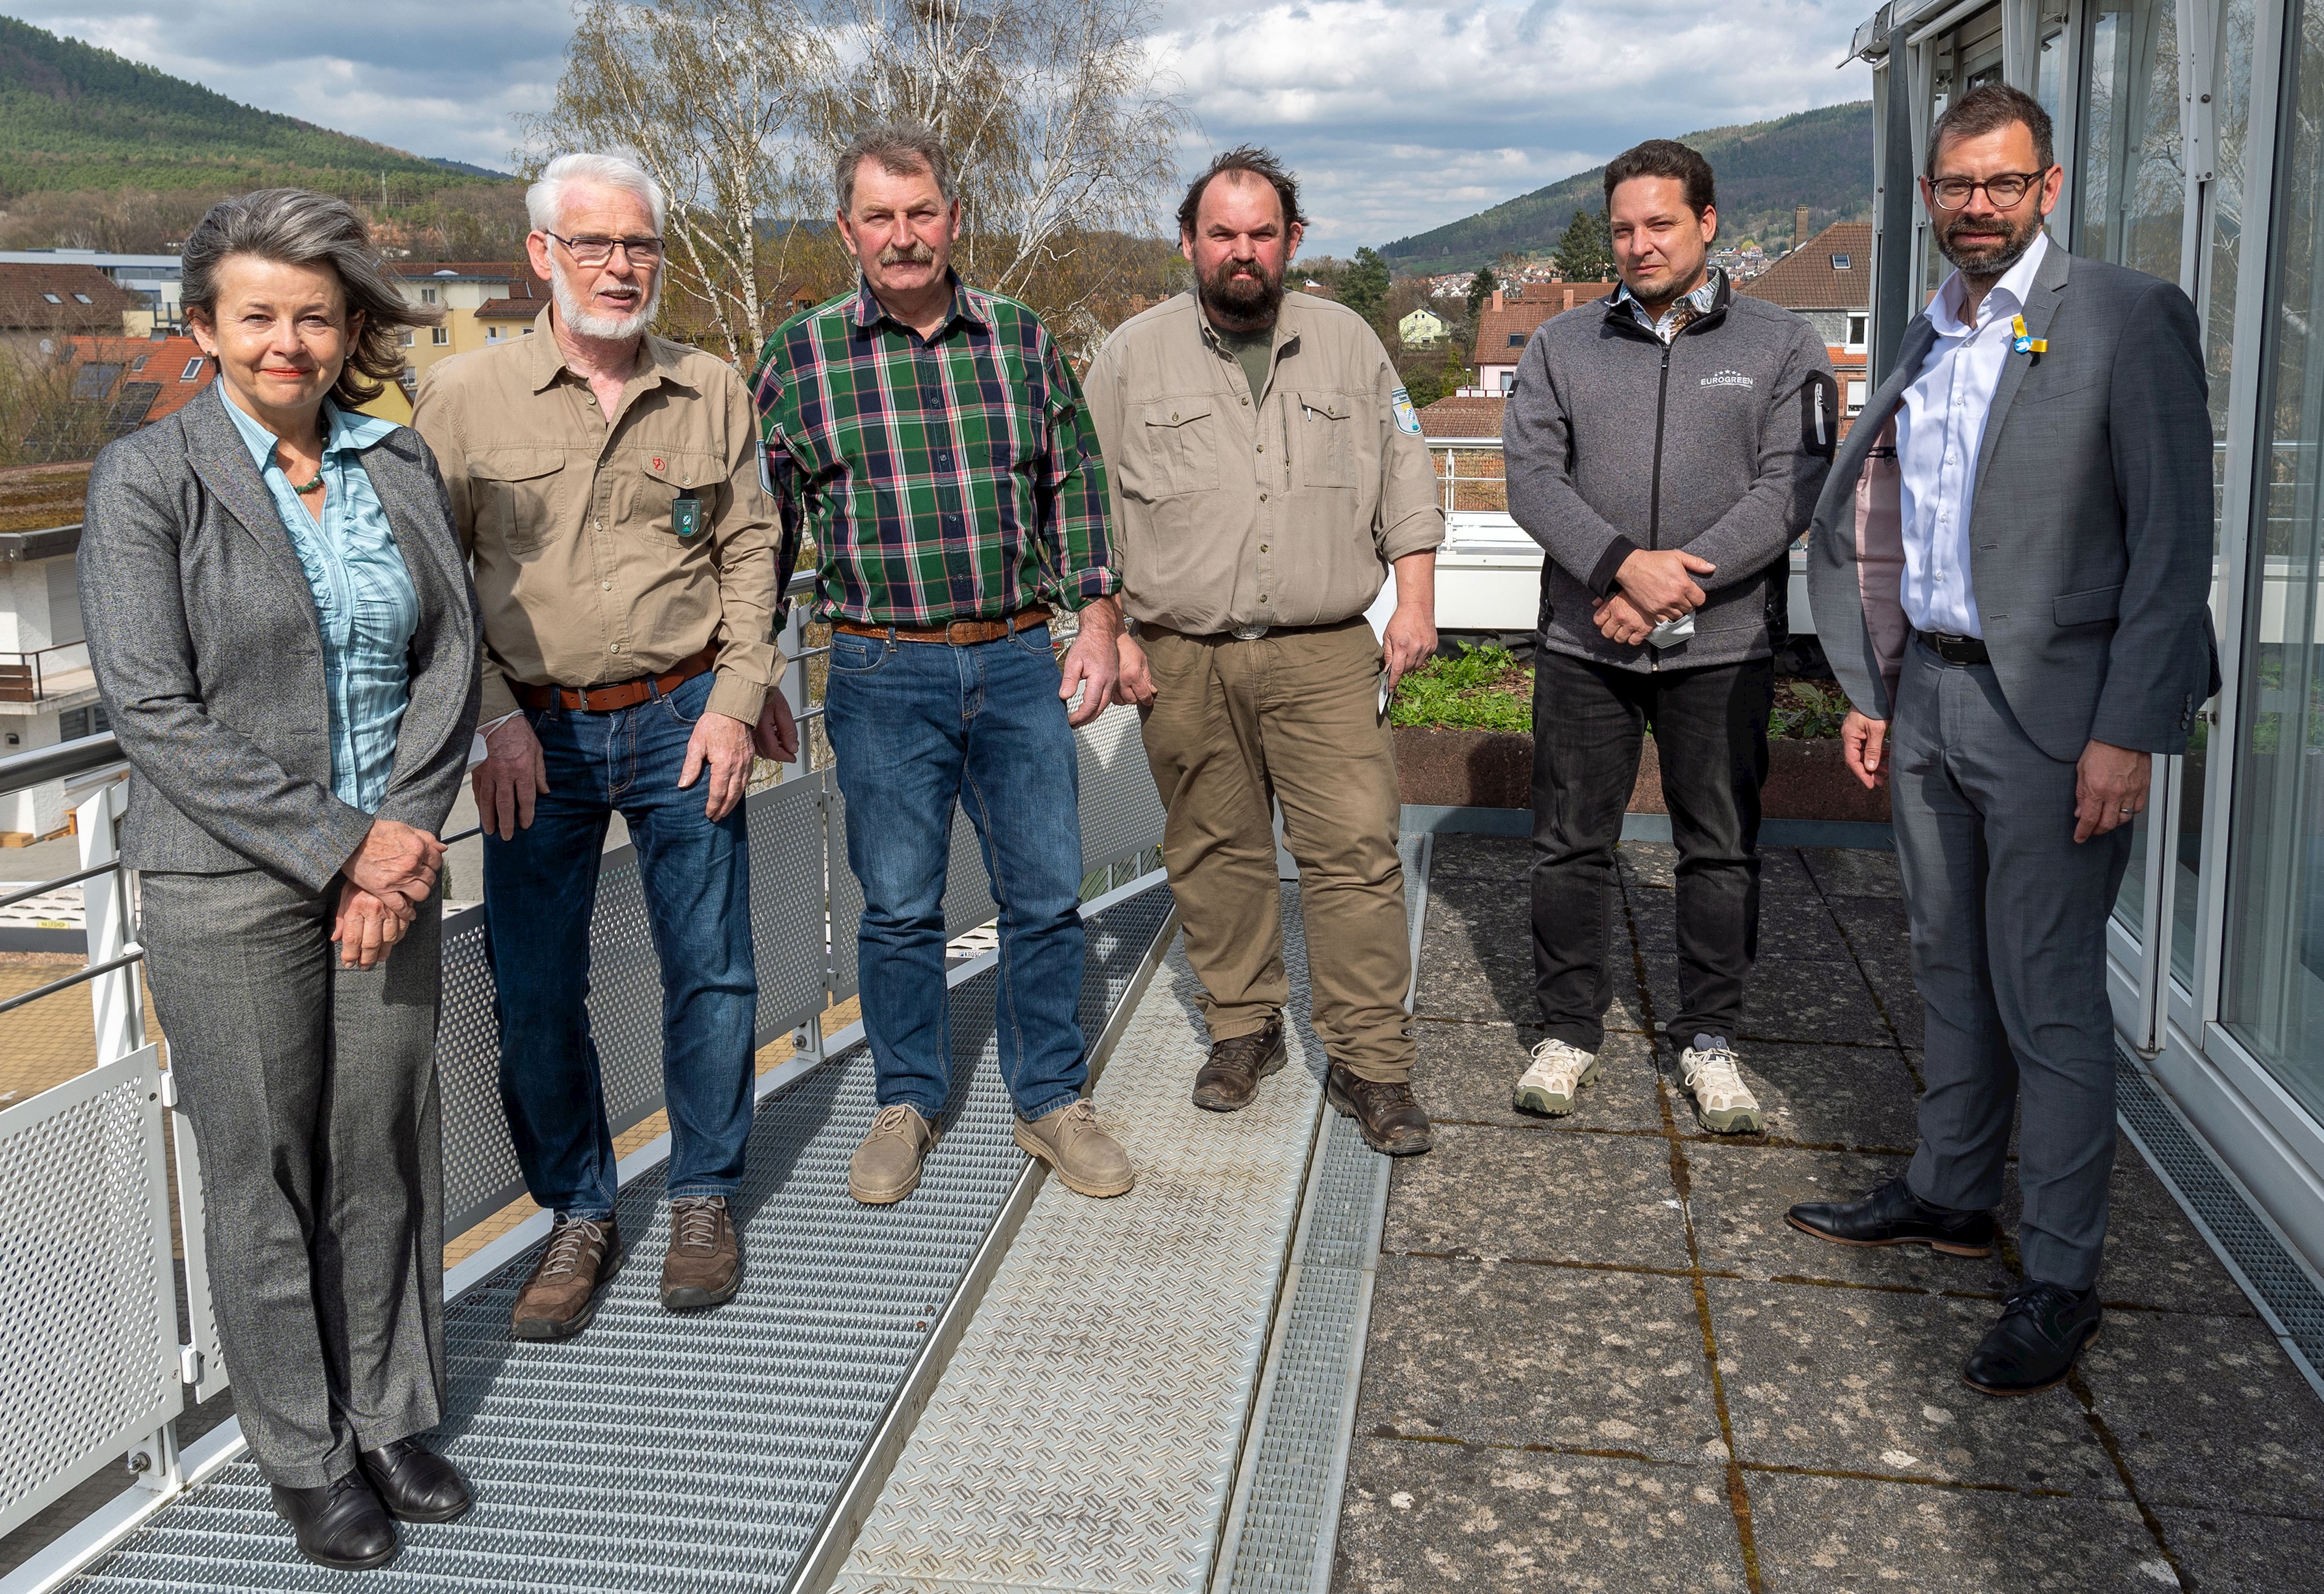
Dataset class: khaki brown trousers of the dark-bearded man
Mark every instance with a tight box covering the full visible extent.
[1141,618,1413,1083]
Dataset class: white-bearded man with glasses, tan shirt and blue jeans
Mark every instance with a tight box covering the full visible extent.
[411,153,797,1338]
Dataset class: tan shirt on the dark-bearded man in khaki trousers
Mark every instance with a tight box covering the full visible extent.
[1083,293,1446,634]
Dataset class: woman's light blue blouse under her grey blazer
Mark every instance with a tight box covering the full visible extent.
[225,400,418,813]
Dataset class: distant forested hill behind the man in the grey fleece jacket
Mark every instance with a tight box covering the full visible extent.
[1380,100,1873,274]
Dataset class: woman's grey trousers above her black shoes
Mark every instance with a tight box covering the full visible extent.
[140,869,444,1490]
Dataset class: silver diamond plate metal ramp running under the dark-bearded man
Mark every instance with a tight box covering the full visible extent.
[832,860,1411,1594]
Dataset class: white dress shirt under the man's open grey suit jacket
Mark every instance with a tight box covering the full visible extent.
[1896,233,2050,636]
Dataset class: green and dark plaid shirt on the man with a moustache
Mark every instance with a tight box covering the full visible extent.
[753,276,1120,627]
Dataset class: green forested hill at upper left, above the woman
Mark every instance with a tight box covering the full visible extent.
[0,16,477,204]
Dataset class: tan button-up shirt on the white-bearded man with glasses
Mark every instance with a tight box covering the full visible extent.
[411,309,783,720]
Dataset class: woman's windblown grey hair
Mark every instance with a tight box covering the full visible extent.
[181,188,444,409]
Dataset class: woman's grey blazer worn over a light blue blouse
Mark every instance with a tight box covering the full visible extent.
[79,383,479,892]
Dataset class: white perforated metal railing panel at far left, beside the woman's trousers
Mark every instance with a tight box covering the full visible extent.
[0,1045,184,1533]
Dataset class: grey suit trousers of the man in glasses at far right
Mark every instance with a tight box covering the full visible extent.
[1889,642,2131,1289]
